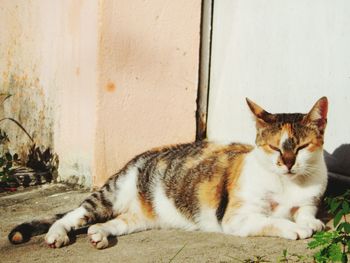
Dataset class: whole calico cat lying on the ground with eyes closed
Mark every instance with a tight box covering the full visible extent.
[9,97,328,249]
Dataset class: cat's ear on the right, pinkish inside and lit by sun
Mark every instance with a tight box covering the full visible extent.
[304,97,328,132]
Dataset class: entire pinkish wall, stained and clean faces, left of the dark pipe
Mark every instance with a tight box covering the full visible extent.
[0,0,201,189]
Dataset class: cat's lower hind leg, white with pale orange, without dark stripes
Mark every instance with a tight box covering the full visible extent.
[88,213,155,249]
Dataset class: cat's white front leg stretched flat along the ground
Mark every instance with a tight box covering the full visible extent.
[222,213,312,240]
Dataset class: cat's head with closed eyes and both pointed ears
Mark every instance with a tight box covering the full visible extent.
[247,97,328,176]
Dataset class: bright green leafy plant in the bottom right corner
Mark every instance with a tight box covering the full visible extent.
[308,190,350,263]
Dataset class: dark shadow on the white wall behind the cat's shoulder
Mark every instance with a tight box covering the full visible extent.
[324,144,350,195]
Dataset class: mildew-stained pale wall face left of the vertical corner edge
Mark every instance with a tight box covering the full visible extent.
[0,0,98,185]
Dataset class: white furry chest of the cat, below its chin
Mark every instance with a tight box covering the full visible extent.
[240,156,322,218]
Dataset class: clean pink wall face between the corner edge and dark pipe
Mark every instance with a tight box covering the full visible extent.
[93,0,201,185]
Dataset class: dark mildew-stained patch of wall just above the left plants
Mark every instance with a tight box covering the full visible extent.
[0,72,53,154]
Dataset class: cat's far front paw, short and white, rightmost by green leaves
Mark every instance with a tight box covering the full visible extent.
[293,205,325,231]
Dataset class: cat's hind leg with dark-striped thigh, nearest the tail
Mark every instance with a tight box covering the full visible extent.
[45,189,113,248]
